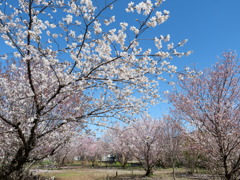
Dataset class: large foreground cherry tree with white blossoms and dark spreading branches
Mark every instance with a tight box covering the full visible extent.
[0,0,191,179]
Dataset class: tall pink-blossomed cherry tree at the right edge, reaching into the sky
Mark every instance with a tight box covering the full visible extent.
[170,52,240,180]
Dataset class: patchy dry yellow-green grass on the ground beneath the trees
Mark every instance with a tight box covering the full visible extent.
[38,168,206,180]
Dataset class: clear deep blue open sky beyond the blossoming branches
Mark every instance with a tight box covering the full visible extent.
[137,0,240,117]
